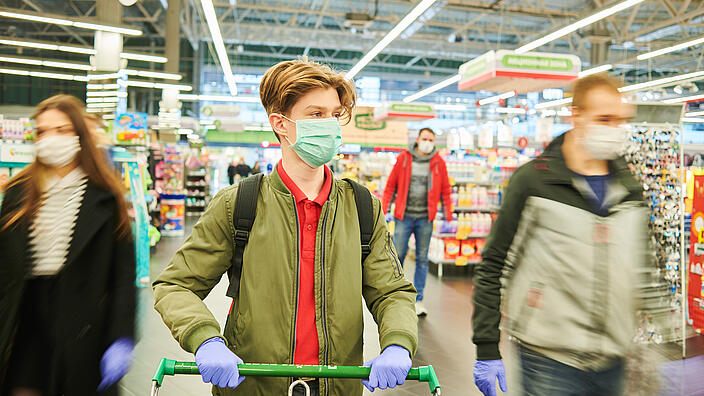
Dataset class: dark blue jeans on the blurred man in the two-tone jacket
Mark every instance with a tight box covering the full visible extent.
[519,346,624,396]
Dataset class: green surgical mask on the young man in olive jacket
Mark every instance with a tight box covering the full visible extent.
[281,114,342,168]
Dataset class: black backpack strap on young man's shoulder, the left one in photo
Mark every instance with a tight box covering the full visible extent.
[227,173,263,299]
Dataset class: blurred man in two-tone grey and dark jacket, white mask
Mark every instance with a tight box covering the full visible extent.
[473,75,648,396]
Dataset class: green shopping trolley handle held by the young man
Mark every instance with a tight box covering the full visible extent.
[151,359,440,396]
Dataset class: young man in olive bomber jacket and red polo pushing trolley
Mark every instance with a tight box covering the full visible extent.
[154,60,418,396]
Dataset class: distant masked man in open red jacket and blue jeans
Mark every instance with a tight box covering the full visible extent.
[382,128,452,316]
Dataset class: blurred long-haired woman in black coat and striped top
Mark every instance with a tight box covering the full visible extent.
[0,95,135,395]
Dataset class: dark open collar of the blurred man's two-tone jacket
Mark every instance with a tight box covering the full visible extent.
[535,131,640,201]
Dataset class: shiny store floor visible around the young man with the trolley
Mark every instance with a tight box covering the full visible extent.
[120,223,500,396]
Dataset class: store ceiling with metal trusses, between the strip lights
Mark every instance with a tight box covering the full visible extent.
[0,0,704,81]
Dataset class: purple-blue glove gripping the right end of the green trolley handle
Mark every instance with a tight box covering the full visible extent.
[362,345,413,392]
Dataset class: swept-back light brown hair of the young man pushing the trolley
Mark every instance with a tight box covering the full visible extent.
[259,58,357,124]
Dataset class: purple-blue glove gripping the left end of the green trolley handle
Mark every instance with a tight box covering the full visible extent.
[196,337,245,389]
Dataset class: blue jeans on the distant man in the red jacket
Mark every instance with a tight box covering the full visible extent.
[394,217,433,301]
